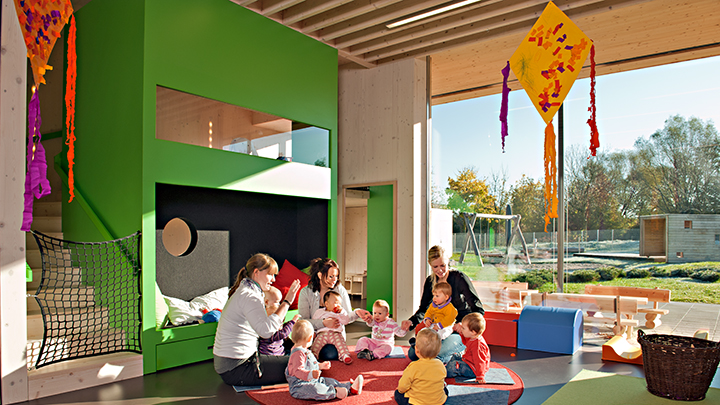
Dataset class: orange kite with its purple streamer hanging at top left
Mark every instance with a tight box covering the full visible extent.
[15,0,74,231]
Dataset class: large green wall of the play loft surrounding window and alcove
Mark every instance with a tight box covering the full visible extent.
[63,0,338,373]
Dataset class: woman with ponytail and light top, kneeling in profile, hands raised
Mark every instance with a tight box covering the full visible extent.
[213,253,300,385]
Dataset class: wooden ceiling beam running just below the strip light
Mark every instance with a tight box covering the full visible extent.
[344,0,564,55]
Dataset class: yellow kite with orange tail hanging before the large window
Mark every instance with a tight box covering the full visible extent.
[500,2,595,231]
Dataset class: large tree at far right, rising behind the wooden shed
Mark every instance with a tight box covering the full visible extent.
[634,115,720,214]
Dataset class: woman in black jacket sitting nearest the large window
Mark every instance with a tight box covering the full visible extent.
[401,245,485,363]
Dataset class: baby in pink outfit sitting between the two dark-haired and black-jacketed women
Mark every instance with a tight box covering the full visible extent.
[355,300,407,361]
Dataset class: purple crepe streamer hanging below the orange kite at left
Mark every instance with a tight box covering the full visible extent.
[20,91,50,232]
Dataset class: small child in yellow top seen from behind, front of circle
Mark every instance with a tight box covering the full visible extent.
[395,328,448,405]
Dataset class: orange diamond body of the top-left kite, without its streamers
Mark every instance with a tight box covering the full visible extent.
[15,0,73,86]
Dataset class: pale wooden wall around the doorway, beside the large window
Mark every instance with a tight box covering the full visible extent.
[338,59,427,319]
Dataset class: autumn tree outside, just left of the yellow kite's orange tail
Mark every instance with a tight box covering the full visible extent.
[510,175,545,232]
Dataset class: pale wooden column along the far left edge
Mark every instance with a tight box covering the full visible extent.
[0,0,28,404]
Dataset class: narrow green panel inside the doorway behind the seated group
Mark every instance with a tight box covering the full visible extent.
[367,185,394,311]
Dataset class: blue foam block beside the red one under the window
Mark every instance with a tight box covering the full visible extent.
[518,306,583,354]
